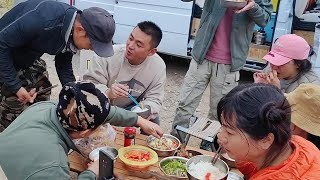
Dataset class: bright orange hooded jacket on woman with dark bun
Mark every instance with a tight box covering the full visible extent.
[237,136,320,180]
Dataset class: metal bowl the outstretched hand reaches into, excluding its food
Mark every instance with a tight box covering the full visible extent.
[146,134,181,157]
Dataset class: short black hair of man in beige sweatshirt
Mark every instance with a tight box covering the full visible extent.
[137,21,162,48]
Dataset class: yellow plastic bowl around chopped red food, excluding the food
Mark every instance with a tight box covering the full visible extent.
[119,145,159,170]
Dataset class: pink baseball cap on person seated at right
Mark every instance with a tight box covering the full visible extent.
[262,34,310,66]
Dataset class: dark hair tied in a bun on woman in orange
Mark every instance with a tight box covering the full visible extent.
[217,83,291,167]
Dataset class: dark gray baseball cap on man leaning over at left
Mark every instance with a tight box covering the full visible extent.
[80,7,115,57]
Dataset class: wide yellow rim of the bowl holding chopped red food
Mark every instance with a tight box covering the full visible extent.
[118,145,159,167]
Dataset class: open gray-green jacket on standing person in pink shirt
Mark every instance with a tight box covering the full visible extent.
[182,0,273,71]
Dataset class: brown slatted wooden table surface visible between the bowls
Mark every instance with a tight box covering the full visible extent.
[68,131,239,180]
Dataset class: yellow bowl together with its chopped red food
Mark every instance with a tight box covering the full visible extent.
[119,145,158,170]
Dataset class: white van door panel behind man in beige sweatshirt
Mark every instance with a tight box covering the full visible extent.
[113,0,193,56]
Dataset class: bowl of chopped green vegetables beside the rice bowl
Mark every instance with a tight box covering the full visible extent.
[159,156,188,179]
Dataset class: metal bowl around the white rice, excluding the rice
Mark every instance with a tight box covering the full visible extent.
[187,155,229,180]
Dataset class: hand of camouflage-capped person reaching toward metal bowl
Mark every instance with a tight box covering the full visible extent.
[136,116,163,138]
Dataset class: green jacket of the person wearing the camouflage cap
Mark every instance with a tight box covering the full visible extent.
[0,101,138,180]
